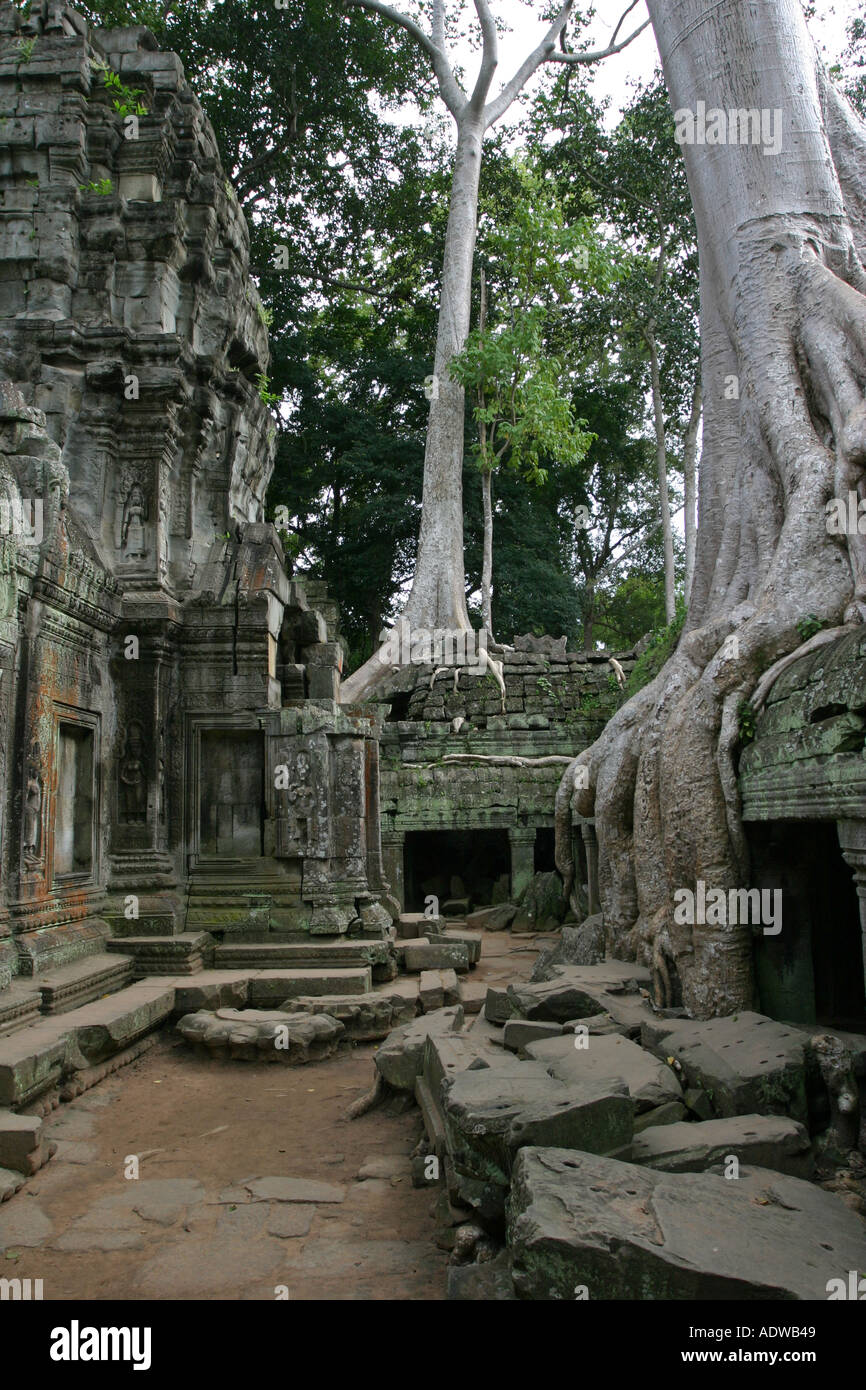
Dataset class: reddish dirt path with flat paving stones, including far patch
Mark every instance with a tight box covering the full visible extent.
[0,934,547,1301]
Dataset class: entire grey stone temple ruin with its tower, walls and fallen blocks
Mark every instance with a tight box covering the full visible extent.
[0,3,866,1298]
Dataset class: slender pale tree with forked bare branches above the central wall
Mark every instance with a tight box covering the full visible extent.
[341,0,648,703]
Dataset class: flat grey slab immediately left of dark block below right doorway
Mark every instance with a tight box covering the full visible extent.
[527,1033,683,1113]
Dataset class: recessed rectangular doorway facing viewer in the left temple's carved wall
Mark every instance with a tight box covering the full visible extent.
[200,728,264,858]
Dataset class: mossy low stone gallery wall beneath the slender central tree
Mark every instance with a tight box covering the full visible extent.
[379,637,635,906]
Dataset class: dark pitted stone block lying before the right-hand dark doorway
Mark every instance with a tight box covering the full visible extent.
[641,1012,809,1123]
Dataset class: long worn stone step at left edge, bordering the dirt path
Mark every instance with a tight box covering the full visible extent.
[0,981,174,1109]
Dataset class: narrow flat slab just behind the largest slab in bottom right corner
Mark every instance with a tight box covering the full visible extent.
[631,1115,815,1179]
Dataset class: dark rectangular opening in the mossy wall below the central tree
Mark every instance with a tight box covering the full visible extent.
[403,830,512,912]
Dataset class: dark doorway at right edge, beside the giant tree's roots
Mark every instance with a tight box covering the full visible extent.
[746,821,866,1033]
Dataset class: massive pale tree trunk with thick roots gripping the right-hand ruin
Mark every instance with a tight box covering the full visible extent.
[556,0,866,1017]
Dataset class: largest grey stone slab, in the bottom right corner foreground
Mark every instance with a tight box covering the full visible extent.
[507,1148,866,1301]
